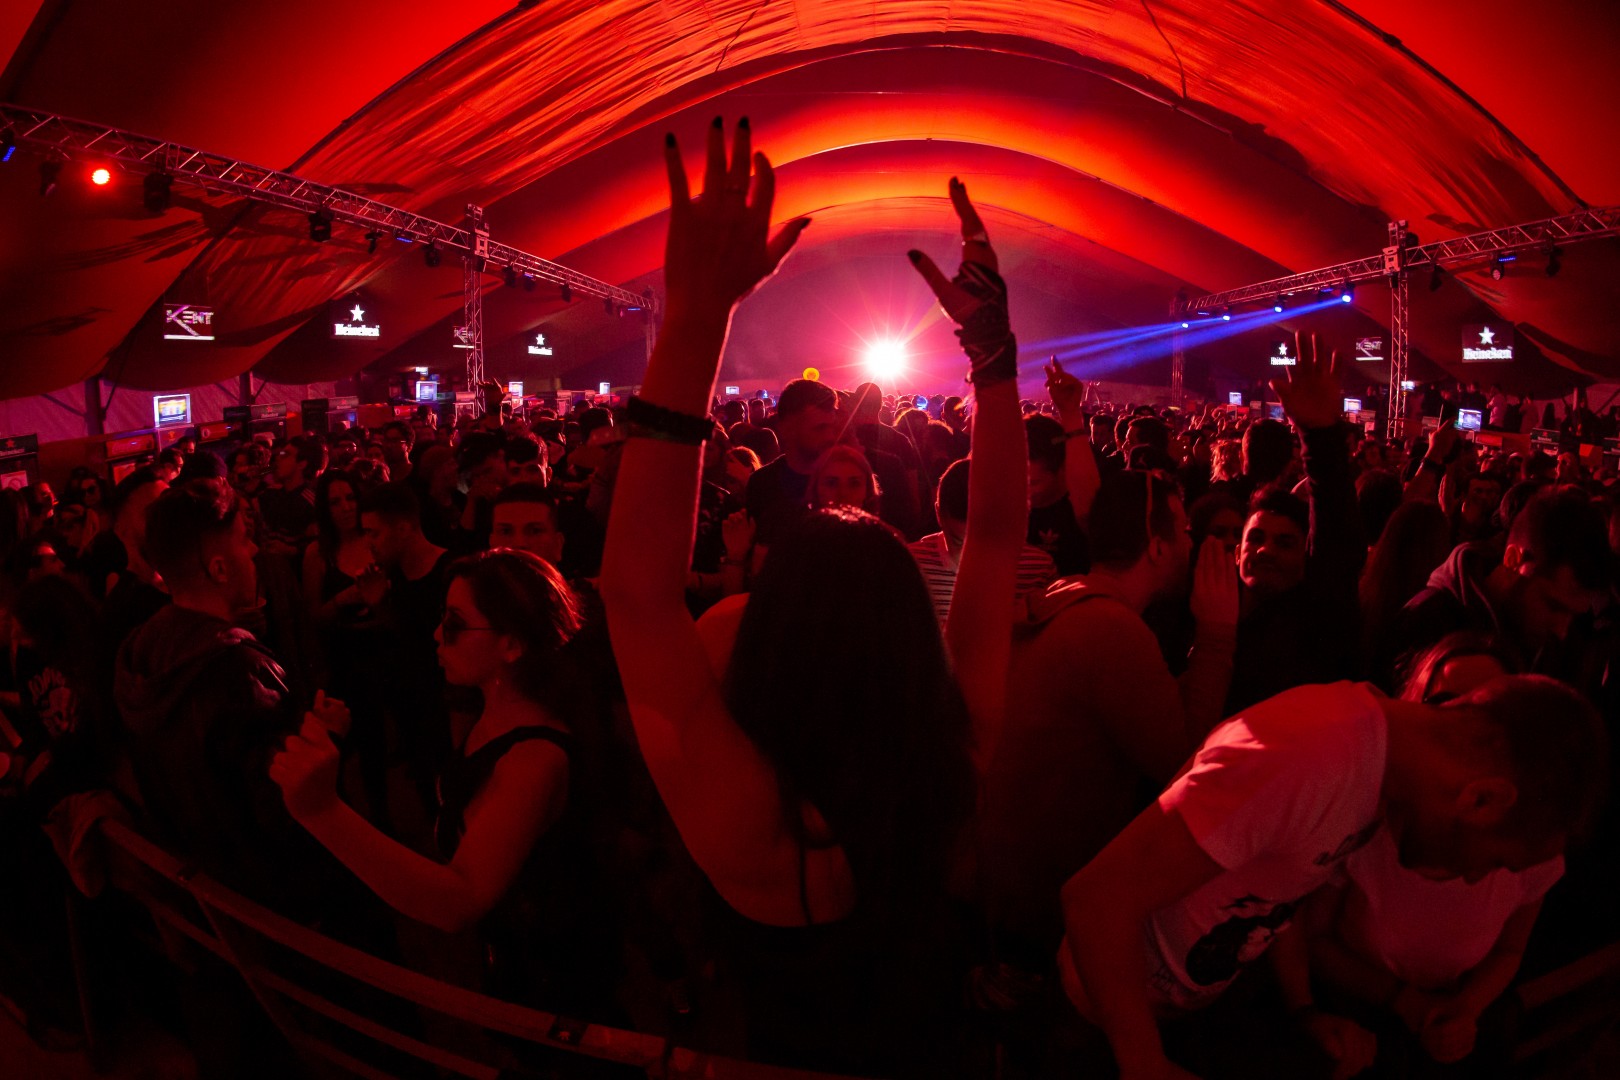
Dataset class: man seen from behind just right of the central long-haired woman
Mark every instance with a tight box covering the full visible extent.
[980,471,1238,968]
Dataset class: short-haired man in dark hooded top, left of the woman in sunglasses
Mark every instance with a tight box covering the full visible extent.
[113,479,332,918]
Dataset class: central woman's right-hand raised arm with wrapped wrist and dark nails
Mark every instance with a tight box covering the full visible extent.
[909,176,1029,769]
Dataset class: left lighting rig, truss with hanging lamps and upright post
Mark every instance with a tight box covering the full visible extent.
[0,104,658,409]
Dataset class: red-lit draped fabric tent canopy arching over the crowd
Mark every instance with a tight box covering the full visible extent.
[0,0,1620,397]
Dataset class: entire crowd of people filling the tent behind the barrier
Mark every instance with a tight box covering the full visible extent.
[0,120,1620,1078]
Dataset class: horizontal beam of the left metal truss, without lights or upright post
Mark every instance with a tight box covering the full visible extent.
[0,104,656,308]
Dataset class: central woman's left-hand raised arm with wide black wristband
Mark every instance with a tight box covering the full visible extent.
[601,118,849,925]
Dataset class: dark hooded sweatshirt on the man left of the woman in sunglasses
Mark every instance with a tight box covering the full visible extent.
[113,604,329,918]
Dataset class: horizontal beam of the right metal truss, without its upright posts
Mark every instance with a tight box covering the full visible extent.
[1178,206,1620,314]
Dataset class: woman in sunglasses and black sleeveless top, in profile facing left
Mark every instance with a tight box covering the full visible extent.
[271,549,617,1017]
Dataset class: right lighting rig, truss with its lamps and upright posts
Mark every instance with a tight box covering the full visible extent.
[1170,206,1620,437]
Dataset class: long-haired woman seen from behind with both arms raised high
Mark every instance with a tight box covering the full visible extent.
[601,120,1027,1075]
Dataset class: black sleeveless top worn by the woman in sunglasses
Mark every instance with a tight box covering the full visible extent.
[433,725,620,1022]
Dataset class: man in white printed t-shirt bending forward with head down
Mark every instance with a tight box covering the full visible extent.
[1059,677,1609,1080]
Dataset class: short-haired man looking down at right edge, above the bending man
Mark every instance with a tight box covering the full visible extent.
[1388,489,1610,675]
